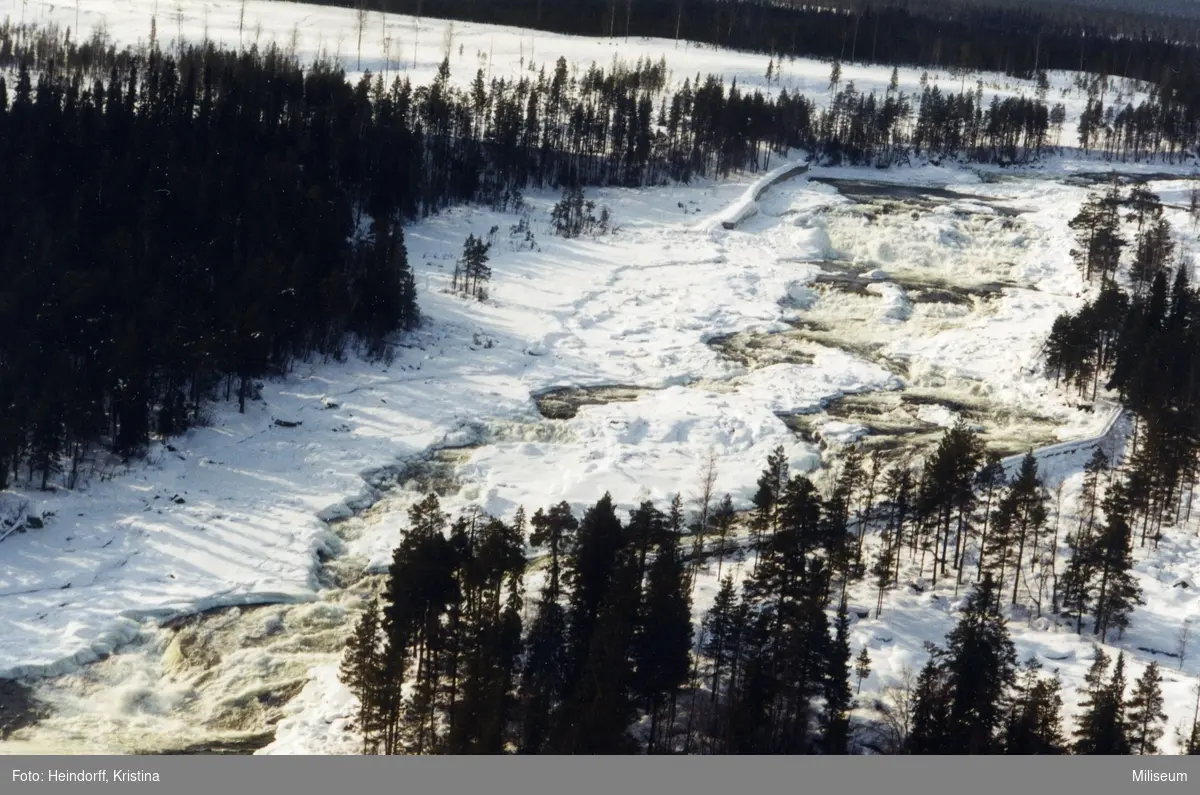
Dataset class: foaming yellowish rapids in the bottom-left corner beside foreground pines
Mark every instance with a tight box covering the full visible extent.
[0,497,388,754]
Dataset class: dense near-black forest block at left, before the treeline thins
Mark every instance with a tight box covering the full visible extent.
[0,39,427,488]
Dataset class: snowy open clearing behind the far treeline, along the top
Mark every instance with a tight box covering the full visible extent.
[9,0,1171,152]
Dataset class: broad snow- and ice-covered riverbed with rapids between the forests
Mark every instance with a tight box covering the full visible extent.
[7,156,1171,753]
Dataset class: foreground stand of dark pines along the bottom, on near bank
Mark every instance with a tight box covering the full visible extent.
[342,425,1162,754]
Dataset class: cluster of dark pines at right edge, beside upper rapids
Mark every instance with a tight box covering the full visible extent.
[1045,184,1200,554]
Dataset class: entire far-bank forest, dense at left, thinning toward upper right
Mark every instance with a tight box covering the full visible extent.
[0,26,1080,488]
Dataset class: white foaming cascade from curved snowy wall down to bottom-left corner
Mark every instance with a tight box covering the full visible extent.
[4,166,1132,753]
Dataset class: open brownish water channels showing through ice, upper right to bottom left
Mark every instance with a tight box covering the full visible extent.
[0,172,1089,753]
